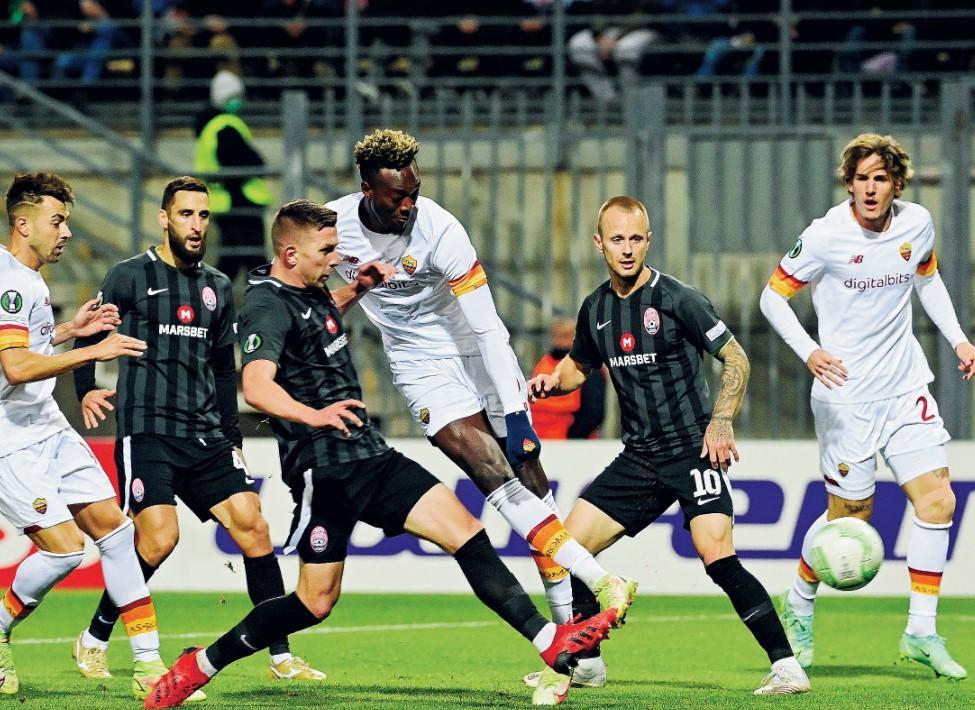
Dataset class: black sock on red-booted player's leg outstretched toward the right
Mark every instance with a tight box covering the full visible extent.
[454,530,548,641]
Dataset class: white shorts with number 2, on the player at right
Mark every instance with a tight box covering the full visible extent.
[812,386,951,500]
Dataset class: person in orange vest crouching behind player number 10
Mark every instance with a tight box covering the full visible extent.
[531,318,606,439]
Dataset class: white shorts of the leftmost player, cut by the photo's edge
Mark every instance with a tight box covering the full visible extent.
[0,428,115,534]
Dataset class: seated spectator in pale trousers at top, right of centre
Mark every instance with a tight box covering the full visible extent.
[569,0,660,103]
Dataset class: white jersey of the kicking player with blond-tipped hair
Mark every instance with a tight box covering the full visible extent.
[327,192,508,362]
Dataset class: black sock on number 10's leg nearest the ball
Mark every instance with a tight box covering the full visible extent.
[704,555,793,663]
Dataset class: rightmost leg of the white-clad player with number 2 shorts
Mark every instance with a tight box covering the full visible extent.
[890,464,968,680]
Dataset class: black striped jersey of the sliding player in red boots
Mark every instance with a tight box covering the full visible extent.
[240,266,389,476]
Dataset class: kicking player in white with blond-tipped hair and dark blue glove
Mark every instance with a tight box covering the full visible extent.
[328,129,636,704]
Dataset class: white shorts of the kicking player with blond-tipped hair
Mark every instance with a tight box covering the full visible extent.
[390,353,531,437]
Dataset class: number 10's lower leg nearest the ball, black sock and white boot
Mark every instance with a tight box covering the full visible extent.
[690,513,809,695]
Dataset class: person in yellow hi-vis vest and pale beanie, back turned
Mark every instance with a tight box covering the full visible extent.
[193,69,273,281]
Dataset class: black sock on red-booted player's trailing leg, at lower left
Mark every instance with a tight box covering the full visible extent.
[206,592,319,670]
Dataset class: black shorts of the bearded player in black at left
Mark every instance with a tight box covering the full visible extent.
[115,434,254,520]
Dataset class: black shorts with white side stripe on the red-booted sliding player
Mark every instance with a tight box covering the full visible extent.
[284,449,440,564]
